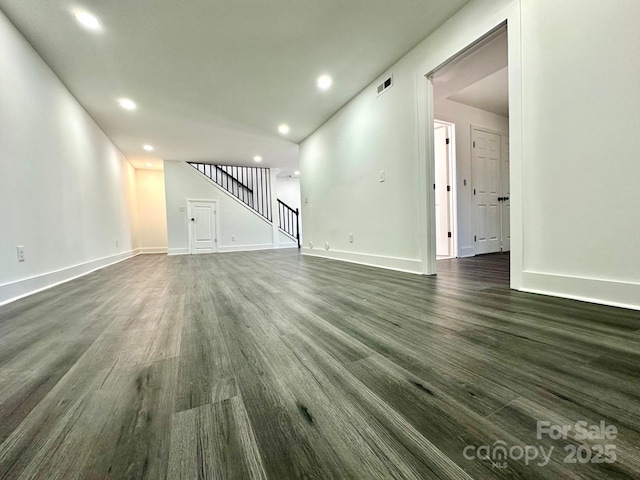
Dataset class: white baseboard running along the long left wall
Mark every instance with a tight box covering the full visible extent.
[0,249,140,305]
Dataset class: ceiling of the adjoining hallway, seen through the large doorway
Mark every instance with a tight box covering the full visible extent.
[433,29,509,117]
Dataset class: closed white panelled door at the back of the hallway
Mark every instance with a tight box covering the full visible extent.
[471,129,502,255]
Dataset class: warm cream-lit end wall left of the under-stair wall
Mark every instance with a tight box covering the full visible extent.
[136,169,168,253]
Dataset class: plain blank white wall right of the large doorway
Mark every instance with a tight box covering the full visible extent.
[522,0,640,307]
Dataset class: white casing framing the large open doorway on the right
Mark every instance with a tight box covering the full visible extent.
[415,7,524,289]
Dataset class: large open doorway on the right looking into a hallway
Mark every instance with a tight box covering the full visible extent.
[430,25,511,270]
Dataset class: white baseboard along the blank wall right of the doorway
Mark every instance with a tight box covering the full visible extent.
[520,271,640,310]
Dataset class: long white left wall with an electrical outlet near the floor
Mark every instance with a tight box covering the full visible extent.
[0,12,137,303]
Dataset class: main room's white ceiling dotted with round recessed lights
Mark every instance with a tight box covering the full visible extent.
[0,0,468,170]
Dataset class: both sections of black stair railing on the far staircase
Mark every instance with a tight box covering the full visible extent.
[187,162,300,248]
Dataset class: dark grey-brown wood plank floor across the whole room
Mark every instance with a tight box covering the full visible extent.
[0,250,640,480]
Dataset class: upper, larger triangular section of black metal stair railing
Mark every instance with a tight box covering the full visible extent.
[187,162,272,222]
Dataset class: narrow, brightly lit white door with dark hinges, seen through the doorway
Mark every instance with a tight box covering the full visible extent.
[434,124,452,257]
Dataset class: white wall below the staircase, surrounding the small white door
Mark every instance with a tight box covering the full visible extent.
[164,161,291,255]
